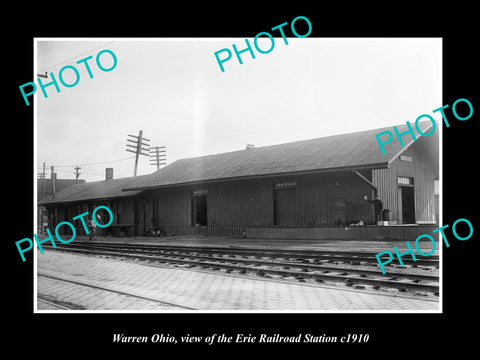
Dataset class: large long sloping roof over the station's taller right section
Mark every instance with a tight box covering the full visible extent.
[124,122,438,190]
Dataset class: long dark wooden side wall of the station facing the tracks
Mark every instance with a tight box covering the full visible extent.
[146,171,374,228]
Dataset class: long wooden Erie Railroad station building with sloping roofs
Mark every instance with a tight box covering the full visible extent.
[42,124,439,239]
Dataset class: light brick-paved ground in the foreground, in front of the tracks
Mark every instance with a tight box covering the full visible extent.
[35,249,440,313]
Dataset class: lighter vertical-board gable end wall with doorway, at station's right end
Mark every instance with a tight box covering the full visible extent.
[373,139,438,222]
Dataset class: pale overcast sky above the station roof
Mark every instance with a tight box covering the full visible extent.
[35,38,443,181]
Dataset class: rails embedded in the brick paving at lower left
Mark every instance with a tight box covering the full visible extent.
[37,272,196,310]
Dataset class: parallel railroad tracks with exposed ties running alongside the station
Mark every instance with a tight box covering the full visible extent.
[42,243,439,296]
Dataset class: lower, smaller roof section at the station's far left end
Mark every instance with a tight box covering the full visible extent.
[38,175,145,205]
